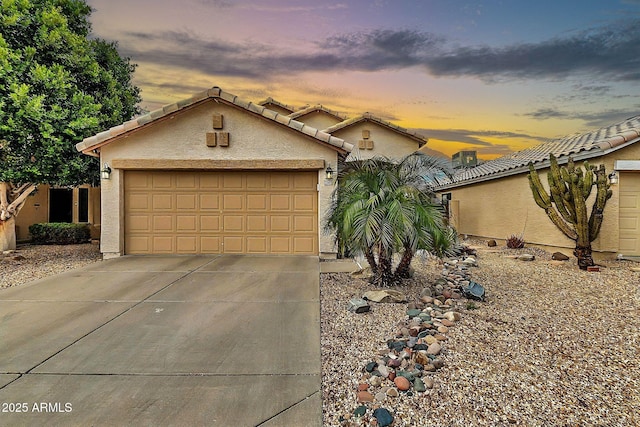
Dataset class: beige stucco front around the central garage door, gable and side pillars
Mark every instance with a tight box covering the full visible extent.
[95,99,338,258]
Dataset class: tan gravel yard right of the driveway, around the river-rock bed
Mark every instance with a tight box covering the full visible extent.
[321,242,640,427]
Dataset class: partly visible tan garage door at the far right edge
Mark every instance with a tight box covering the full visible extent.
[619,172,640,256]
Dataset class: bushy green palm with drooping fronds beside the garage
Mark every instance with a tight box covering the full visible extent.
[325,153,454,286]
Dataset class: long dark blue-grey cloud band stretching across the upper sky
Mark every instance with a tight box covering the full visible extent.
[120,18,640,85]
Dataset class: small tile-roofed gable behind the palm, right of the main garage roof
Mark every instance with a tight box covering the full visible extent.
[324,113,428,160]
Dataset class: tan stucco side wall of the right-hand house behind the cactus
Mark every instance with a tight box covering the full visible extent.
[443,144,640,252]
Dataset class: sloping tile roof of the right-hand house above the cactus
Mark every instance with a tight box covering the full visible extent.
[441,115,640,189]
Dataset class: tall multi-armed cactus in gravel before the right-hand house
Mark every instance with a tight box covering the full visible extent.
[529,155,612,270]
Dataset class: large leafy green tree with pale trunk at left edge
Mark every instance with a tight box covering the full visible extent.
[0,0,140,250]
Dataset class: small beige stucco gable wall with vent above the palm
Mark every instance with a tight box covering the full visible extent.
[332,121,418,160]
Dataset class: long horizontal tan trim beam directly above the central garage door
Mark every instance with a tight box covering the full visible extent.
[111,159,325,170]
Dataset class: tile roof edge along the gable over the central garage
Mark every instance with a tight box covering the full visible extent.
[76,86,353,155]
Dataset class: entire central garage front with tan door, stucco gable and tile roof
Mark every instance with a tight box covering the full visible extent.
[76,87,353,258]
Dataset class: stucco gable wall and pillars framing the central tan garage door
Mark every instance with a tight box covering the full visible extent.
[101,100,337,257]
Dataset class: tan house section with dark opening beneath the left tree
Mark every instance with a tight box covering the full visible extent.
[16,184,100,241]
